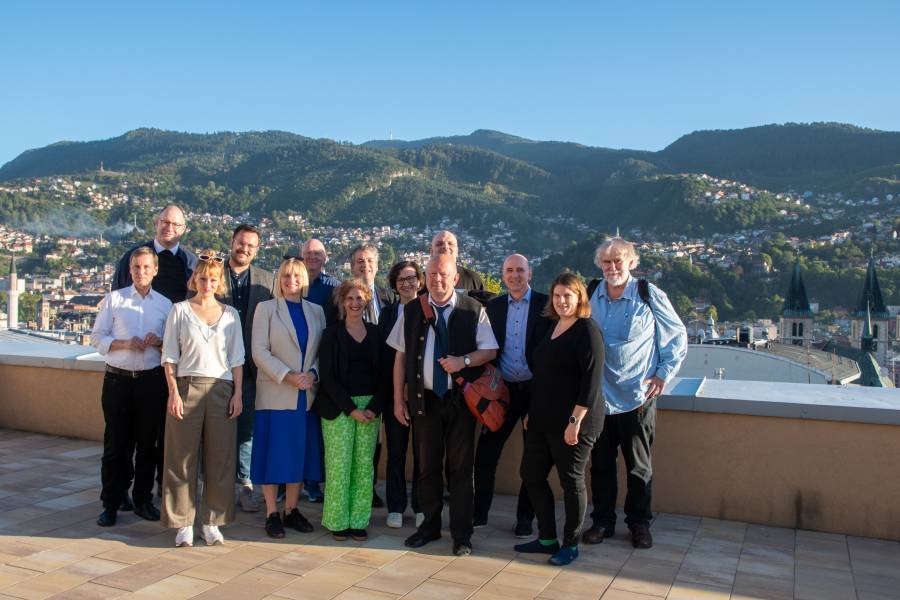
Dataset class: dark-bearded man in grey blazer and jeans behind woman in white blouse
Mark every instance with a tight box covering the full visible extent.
[218,224,274,512]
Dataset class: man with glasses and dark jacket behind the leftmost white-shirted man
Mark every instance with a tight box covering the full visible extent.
[112,204,197,304]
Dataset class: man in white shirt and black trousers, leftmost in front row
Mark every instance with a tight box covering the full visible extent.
[91,246,172,527]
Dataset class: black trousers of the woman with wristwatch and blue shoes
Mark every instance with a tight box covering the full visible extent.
[521,430,594,546]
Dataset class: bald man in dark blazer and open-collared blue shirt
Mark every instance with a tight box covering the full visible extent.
[473,254,551,538]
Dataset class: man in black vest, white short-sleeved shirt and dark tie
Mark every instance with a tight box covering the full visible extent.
[388,254,497,556]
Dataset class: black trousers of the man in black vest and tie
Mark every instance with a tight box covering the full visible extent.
[413,390,475,542]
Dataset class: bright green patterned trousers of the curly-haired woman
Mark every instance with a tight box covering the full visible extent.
[322,396,381,531]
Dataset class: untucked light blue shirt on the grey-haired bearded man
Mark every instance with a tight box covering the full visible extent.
[591,277,687,415]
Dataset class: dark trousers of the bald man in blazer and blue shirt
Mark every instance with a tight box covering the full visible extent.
[475,381,534,523]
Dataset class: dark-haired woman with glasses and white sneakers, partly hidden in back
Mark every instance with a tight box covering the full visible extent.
[376,260,425,528]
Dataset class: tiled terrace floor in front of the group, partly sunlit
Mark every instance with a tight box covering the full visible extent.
[0,430,900,600]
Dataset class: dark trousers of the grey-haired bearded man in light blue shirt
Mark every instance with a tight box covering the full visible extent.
[591,398,656,528]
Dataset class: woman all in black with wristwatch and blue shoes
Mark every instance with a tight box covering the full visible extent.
[515,273,604,565]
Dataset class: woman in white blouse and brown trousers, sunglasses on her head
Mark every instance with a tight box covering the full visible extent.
[162,250,244,546]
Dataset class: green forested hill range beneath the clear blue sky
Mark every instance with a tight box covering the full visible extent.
[0,124,900,235]
